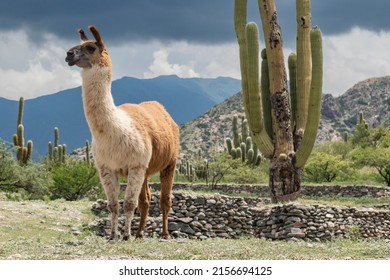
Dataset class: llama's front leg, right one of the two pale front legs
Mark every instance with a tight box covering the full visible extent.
[123,167,146,240]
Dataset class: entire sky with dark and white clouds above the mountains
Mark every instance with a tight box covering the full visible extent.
[0,0,390,100]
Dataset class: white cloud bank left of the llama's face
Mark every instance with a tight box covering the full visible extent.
[0,30,81,100]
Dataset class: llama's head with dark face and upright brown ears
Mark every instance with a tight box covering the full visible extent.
[65,26,111,68]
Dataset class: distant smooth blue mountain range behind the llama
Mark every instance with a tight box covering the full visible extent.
[0,76,241,158]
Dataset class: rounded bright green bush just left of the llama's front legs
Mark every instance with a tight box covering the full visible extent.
[50,161,102,201]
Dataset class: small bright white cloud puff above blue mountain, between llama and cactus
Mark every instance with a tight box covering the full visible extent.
[144,49,199,78]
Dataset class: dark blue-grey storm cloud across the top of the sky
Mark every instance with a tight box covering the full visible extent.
[0,0,390,43]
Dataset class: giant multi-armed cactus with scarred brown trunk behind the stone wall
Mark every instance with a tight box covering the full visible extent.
[234,0,322,202]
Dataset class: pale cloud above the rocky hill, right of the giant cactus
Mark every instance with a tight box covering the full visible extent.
[323,27,390,95]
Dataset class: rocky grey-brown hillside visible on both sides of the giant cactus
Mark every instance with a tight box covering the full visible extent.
[181,77,390,154]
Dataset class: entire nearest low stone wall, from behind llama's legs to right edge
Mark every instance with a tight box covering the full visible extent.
[91,192,390,241]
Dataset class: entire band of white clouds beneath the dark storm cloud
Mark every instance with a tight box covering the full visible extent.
[0,27,390,100]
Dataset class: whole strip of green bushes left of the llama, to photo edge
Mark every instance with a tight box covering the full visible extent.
[0,138,102,200]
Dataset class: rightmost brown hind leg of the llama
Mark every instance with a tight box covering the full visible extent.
[160,163,176,239]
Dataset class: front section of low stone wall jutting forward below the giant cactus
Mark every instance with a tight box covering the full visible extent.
[251,204,390,241]
